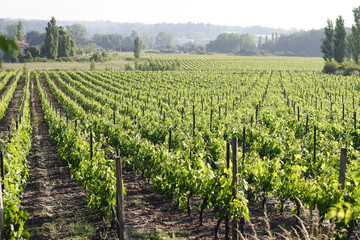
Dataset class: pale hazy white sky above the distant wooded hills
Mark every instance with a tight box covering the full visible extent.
[0,0,360,30]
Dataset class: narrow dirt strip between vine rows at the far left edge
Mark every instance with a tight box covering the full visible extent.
[0,77,25,139]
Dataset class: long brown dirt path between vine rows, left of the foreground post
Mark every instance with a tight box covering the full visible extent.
[22,76,103,239]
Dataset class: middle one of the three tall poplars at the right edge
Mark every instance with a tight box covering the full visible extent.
[334,16,346,63]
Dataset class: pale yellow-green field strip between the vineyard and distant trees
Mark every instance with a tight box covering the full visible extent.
[4,53,324,72]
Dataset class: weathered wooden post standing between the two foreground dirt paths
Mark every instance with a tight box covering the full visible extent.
[115,149,126,240]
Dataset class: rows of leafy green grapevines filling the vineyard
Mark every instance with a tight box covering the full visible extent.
[0,57,360,239]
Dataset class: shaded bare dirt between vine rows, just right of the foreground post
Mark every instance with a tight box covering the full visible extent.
[124,172,224,239]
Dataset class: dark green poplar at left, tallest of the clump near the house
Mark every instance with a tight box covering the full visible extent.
[42,17,59,59]
